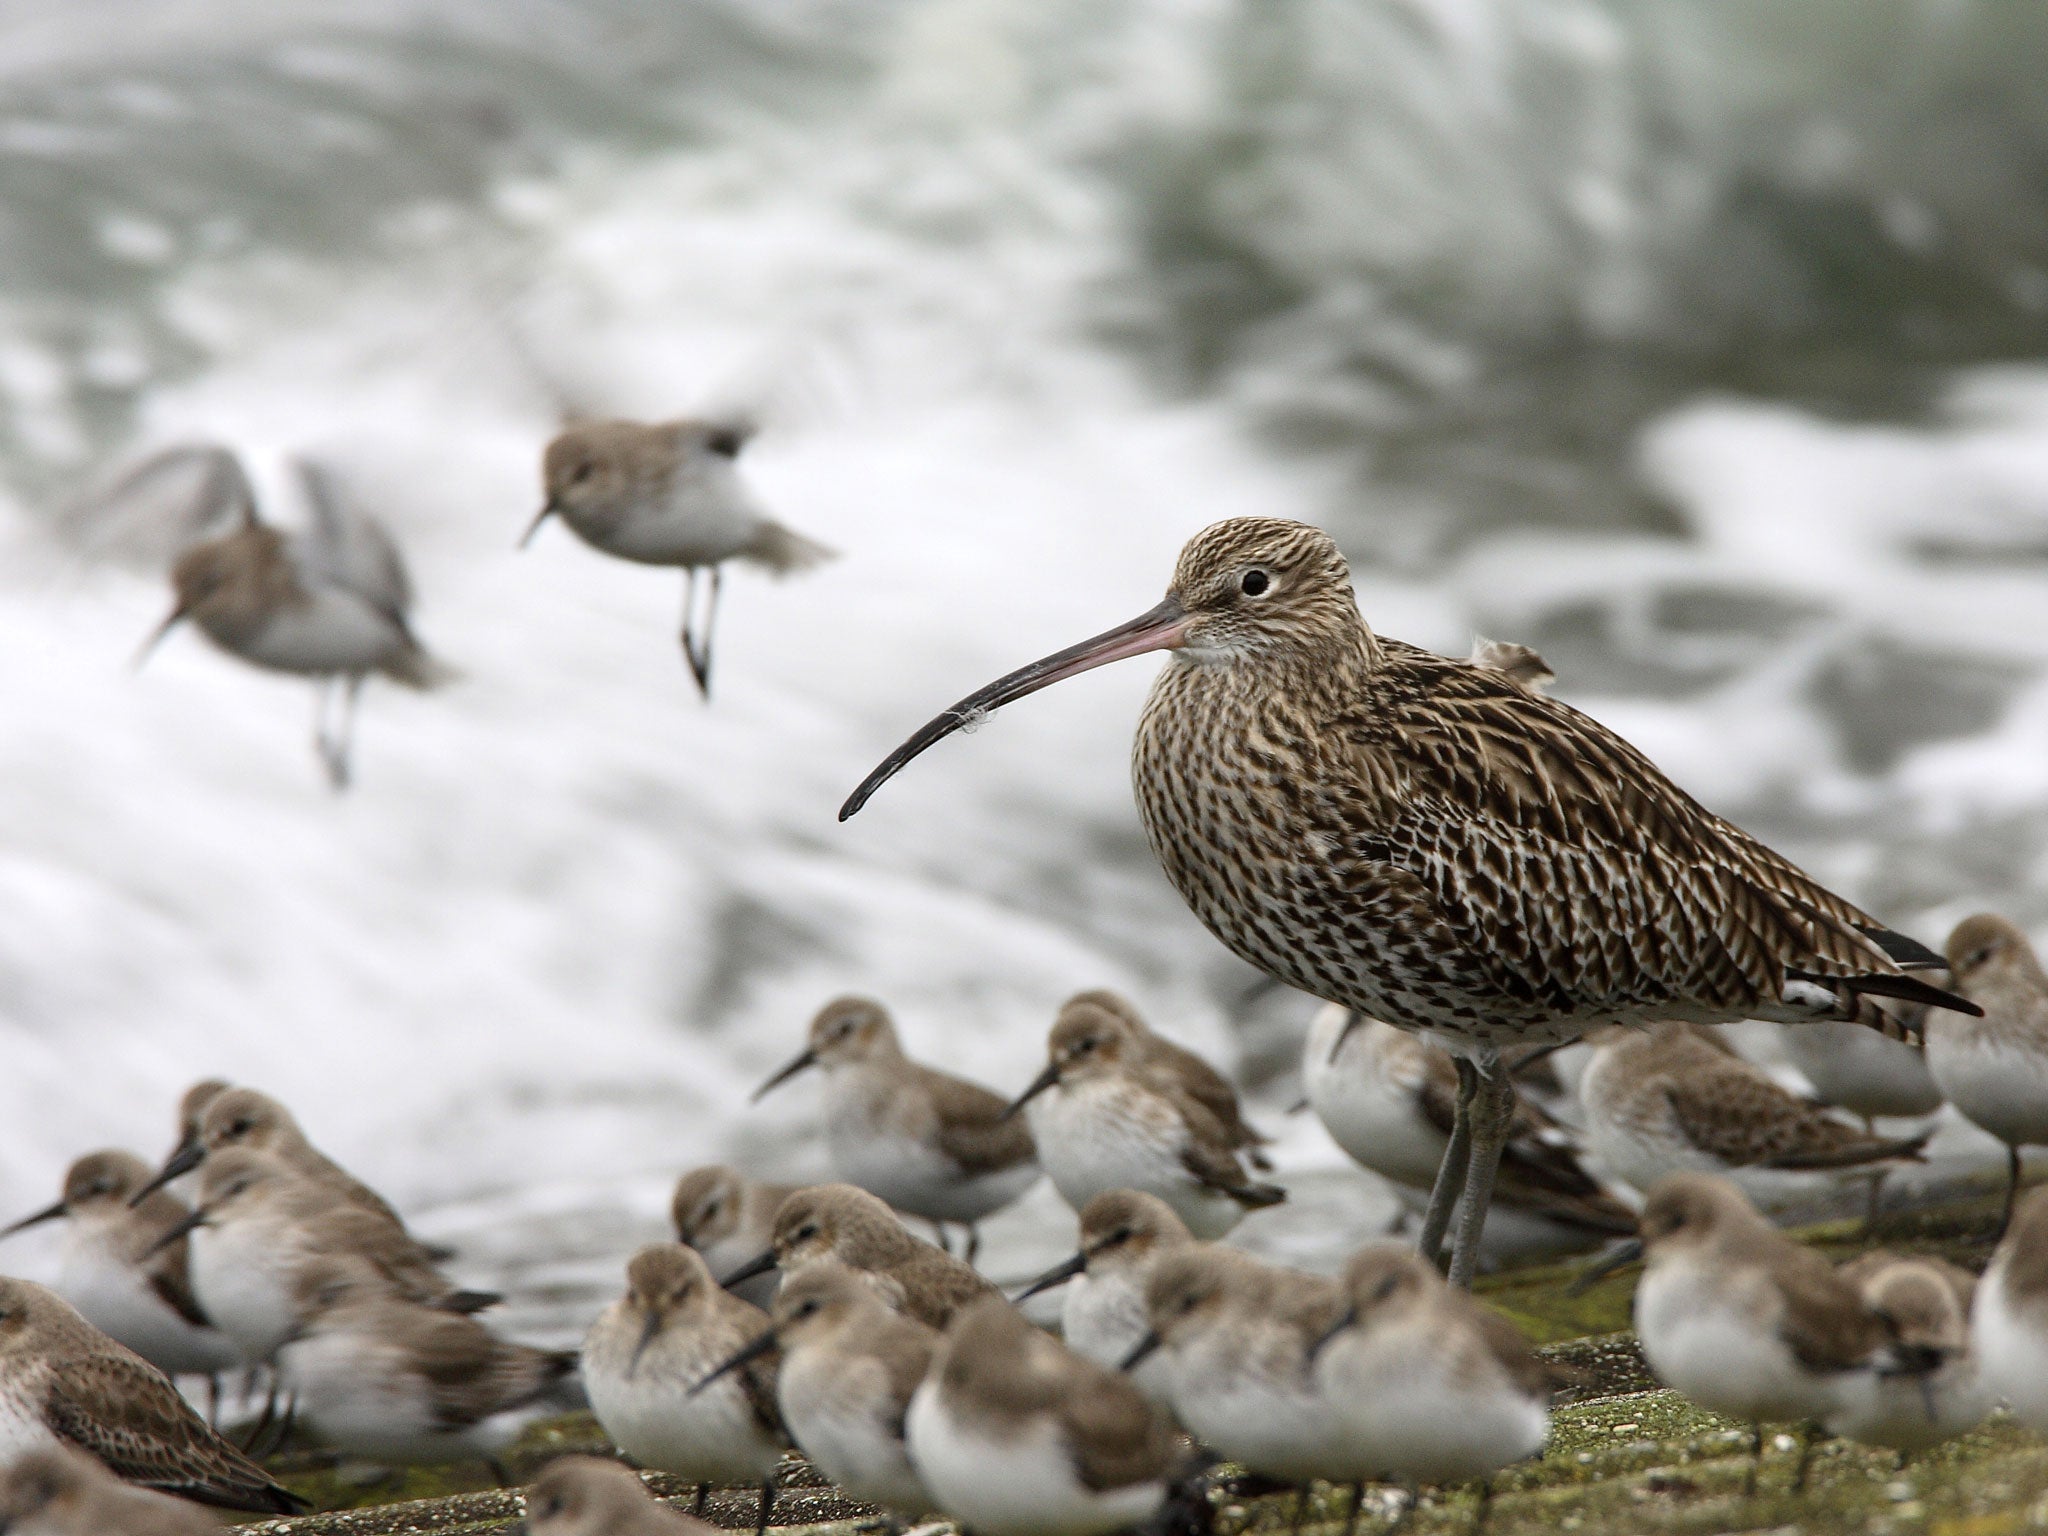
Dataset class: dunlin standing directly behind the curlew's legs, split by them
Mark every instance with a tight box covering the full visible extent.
[1300,1004,1630,1255]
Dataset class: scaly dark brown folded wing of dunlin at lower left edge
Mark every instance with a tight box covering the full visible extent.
[43,1352,295,1513]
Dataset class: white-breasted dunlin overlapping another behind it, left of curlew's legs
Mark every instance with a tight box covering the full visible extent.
[1010,1006,1286,1237]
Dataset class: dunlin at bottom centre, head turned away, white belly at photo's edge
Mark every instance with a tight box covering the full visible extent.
[905,1296,1176,1536]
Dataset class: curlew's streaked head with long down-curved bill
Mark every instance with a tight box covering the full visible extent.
[840,518,1364,821]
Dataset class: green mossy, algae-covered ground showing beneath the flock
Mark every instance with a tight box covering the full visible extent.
[224,1200,2048,1536]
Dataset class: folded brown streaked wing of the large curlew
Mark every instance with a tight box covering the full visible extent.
[1341,641,1960,1028]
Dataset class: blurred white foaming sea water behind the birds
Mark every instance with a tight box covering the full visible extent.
[0,0,2048,1331]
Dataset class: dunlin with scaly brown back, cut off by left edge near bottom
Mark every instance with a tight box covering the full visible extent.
[0,1276,301,1513]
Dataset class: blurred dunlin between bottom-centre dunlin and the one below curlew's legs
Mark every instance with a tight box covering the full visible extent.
[1124,1245,1351,1487]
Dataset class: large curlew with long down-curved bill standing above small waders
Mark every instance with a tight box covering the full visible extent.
[840,518,1974,1282]
